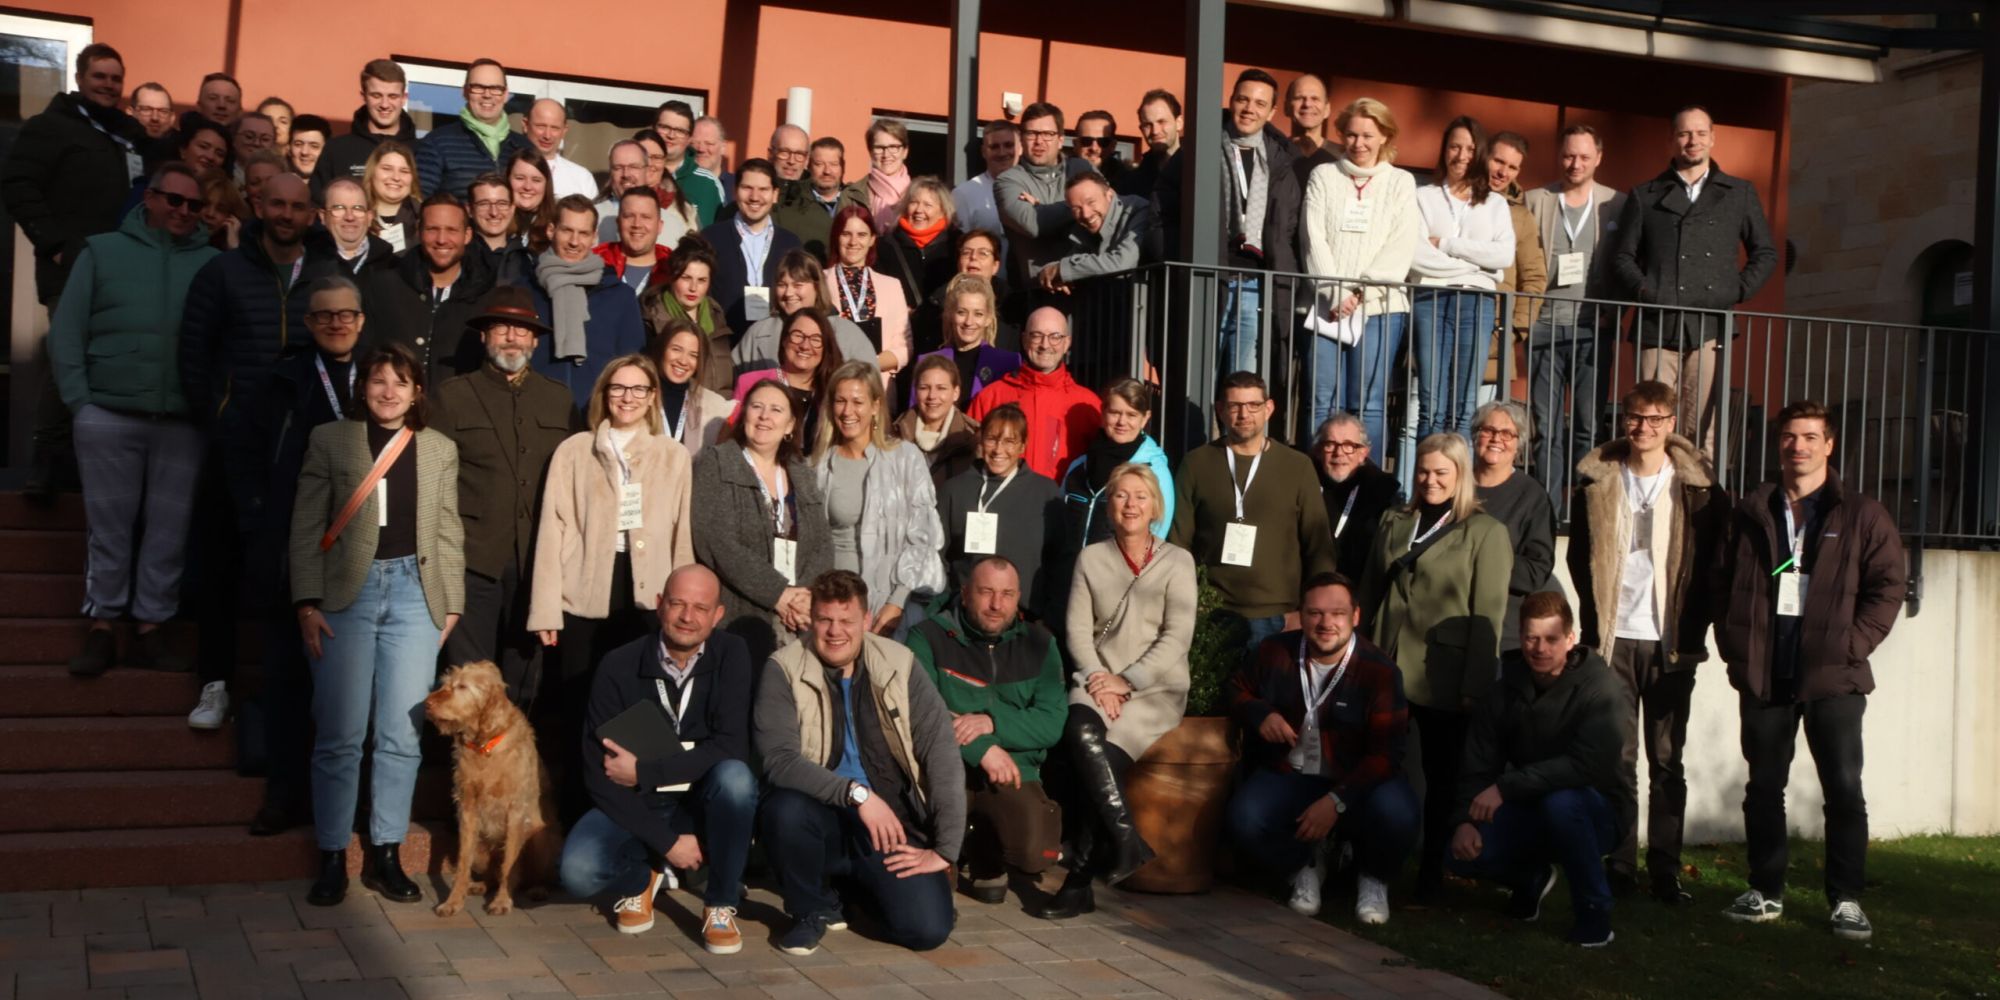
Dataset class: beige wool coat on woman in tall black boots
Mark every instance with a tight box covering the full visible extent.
[1066,538,1198,760]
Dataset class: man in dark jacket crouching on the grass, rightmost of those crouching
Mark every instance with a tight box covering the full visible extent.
[1452,590,1636,948]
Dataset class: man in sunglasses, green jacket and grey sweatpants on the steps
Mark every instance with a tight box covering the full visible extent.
[48,162,220,676]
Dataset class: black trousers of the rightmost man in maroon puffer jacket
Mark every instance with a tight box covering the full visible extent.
[1738,694,1868,904]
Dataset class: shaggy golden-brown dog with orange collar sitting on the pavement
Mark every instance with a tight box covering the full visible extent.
[424,660,562,916]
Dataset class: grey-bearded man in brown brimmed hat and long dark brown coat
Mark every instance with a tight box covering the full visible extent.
[432,284,576,708]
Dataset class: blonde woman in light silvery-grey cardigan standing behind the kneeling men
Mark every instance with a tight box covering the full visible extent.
[812,362,944,636]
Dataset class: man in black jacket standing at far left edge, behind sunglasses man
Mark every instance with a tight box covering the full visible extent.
[0,44,150,496]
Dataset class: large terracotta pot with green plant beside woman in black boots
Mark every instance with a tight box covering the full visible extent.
[1124,570,1250,892]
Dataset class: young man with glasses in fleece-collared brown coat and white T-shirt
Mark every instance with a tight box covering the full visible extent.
[1568,382,1730,906]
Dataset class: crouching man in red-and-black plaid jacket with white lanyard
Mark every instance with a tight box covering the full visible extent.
[1228,572,1422,924]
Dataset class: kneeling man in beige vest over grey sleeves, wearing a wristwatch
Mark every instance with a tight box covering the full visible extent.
[754,570,966,954]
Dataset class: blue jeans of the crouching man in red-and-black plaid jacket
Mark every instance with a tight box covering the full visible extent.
[1224,768,1422,882]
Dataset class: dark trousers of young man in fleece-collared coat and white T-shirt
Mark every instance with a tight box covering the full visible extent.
[1612,638,1694,872]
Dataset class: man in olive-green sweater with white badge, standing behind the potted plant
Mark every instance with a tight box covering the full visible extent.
[1168,372,1334,648]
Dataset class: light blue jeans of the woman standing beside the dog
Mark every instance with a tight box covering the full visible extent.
[308,556,438,850]
